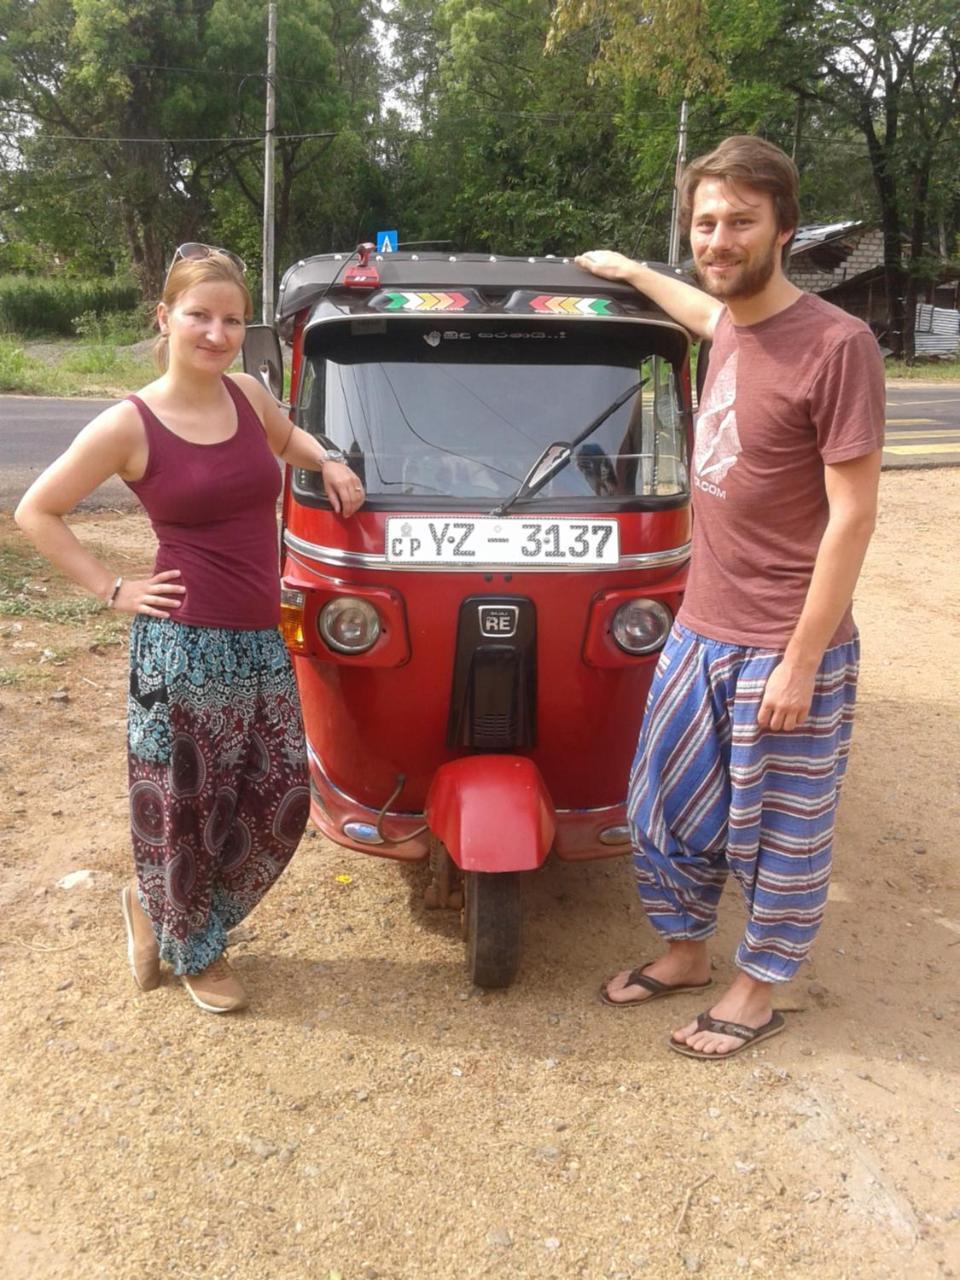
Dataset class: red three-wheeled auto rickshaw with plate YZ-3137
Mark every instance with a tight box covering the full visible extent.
[244,246,692,987]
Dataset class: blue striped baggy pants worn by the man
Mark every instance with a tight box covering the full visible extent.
[627,623,859,982]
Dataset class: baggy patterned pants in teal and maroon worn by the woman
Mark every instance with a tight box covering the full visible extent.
[127,616,310,974]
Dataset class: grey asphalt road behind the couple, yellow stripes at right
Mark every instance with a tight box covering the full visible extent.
[0,383,960,511]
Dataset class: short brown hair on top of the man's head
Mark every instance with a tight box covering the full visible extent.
[680,133,800,266]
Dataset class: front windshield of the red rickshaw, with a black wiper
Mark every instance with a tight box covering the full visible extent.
[296,320,687,507]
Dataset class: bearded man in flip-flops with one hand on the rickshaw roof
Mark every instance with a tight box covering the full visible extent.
[576,137,884,1061]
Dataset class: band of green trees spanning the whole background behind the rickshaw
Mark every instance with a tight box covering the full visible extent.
[0,0,960,358]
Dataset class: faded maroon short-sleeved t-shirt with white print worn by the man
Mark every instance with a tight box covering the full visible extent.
[678,293,886,649]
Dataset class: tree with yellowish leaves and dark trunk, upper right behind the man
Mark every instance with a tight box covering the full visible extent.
[553,0,960,358]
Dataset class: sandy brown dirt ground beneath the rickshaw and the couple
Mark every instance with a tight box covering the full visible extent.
[0,470,960,1280]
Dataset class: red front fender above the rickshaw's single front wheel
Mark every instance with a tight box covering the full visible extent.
[426,755,557,872]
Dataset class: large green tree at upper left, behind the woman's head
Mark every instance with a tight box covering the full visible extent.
[0,0,379,297]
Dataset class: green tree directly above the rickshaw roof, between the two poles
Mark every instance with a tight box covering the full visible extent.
[387,0,647,253]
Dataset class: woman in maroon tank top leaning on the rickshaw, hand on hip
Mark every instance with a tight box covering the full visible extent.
[15,244,364,1012]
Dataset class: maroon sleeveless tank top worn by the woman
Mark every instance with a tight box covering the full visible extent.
[127,378,280,631]
